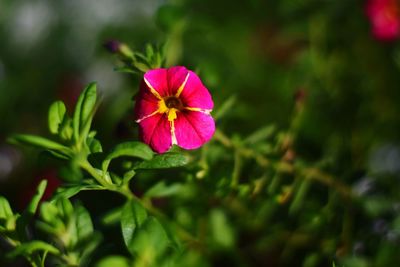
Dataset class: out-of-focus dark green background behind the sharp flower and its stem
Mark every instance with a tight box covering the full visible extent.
[0,0,400,267]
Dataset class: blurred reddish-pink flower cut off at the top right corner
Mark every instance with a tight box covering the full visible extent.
[366,0,400,41]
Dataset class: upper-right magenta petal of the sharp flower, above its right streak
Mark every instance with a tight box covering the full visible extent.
[181,71,214,110]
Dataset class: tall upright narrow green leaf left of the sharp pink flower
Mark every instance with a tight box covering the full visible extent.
[72,83,97,141]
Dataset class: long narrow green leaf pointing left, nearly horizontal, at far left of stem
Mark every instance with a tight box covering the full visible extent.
[8,134,72,157]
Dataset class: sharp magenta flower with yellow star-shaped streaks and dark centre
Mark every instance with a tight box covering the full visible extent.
[135,66,215,153]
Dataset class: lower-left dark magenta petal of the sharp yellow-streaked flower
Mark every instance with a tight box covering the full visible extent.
[139,114,172,153]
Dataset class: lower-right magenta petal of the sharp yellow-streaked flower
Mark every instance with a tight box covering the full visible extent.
[174,111,215,149]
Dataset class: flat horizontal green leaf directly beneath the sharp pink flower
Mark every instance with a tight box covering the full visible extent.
[134,152,189,169]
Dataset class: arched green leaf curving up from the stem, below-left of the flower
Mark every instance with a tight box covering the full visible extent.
[102,142,154,171]
